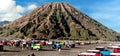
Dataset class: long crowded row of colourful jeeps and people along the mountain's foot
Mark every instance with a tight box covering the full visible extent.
[0,39,83,51]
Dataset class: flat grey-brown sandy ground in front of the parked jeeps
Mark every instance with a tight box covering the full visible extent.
[0,44,109,56]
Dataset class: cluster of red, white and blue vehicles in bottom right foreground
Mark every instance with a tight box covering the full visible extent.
[78,45,120,56]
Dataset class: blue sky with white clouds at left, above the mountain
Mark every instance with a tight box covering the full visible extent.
[0,0,120,33]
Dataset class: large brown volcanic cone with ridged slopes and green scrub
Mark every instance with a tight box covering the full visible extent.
[0,2,117,40]
